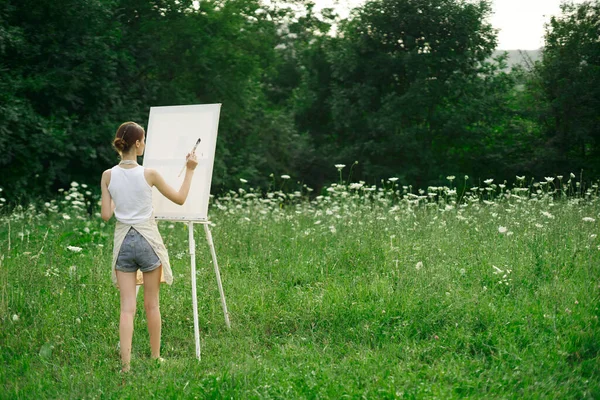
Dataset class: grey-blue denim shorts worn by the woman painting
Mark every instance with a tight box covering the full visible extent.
[115,228,161,272]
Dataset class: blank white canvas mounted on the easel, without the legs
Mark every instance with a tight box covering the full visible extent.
[144,104,221,221]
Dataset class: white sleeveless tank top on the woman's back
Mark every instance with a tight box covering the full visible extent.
[108,165,153,225]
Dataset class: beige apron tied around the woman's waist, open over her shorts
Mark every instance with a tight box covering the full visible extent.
[112,215,173,287]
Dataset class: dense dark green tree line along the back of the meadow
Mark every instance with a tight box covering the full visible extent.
[0,0,600,199]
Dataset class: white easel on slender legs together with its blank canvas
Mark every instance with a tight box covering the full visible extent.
[143,104,231,360]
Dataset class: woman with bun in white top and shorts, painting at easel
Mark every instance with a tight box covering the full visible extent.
[101,122,198,372]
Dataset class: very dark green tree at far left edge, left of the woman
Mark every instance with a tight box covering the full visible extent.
[0,0,119,198]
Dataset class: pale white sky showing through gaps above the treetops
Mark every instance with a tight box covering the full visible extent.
[313,0,583,50]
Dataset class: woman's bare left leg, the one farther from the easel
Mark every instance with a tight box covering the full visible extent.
[117,271,136,372]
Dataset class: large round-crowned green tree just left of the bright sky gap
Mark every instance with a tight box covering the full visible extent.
[298,0,496,185]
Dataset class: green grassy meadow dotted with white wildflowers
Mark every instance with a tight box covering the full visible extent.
[0,173,600,399]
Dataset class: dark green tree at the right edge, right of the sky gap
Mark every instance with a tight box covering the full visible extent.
[536,0,600,174]
